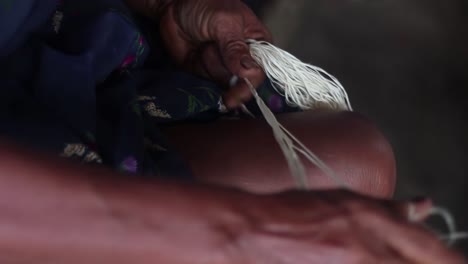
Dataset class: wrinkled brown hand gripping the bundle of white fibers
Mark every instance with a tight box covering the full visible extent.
[160,0,272,108]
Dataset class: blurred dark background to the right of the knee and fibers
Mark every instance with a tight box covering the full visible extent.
[247,0,468,255]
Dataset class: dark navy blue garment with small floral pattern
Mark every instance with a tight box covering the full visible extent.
[0,0,294,178]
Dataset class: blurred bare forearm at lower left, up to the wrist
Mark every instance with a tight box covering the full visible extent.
[0,143,248,264]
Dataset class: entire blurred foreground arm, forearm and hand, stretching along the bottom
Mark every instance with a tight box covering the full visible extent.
[0,144,465,264]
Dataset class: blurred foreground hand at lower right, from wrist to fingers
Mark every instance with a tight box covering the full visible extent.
[230,191,465,264]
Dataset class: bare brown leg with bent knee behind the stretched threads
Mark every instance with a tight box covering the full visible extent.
[164,111,396,199]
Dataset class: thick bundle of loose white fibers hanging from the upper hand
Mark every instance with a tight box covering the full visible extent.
[247,40,352,111]
